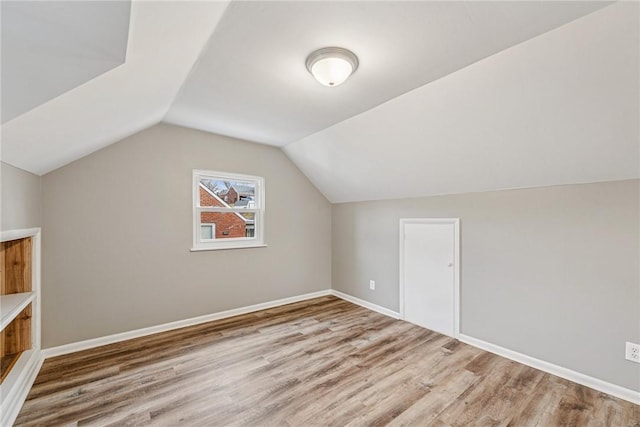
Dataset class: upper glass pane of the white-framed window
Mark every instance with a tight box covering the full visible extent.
[200,178,256,208]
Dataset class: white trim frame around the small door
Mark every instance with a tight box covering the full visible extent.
[399,218,460,338]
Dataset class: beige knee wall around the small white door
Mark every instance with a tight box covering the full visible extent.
[332,180,640,390]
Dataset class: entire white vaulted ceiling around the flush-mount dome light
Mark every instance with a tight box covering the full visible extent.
[2,0,640,202]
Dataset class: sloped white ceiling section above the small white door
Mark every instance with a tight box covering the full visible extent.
[284,2,640,202]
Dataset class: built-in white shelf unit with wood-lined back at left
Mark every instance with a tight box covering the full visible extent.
[0,228,42,425]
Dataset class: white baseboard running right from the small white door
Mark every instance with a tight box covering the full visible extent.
[458,334,640,405]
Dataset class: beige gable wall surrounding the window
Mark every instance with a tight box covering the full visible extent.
[42,125,331,348]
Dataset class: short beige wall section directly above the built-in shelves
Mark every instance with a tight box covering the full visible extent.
[0,162,41,230]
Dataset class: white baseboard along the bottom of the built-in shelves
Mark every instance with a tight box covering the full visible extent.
[0,349,44,426]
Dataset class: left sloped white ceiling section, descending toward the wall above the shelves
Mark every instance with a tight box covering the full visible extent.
[2,1,227,175]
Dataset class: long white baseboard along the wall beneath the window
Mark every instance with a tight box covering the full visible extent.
[42,289,331,359]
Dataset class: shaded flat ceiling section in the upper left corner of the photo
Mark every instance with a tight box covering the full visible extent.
[1,0,131,123]
